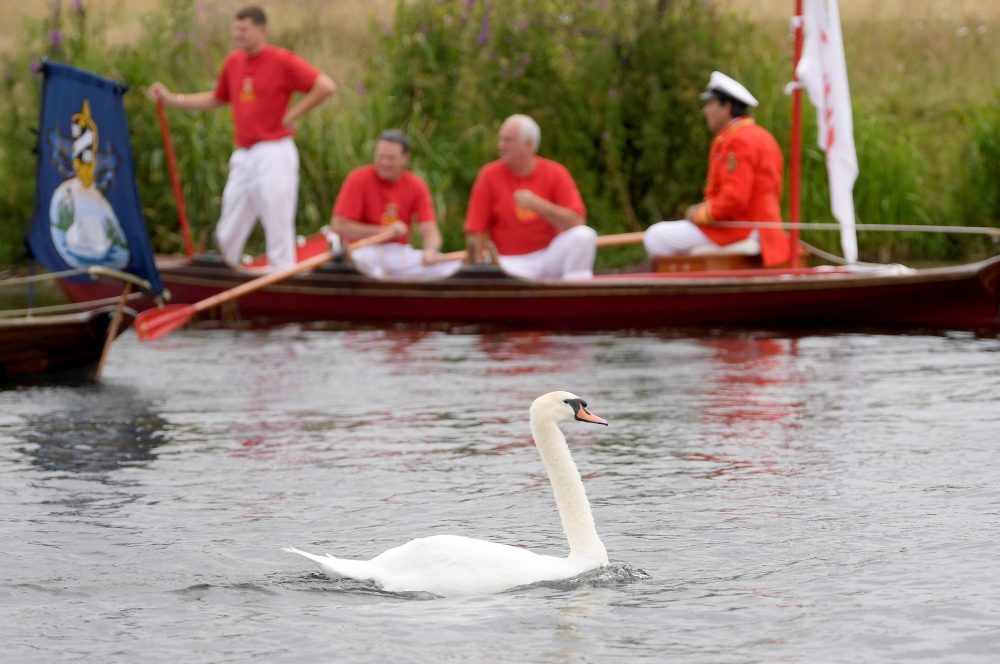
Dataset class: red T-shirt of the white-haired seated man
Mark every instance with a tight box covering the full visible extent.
[465,157,587,256]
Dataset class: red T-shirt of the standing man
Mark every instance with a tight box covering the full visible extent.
[215,45,319,148]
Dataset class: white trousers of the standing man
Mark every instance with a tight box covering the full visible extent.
[215,136,299,270]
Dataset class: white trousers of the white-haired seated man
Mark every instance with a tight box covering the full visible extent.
[500,226,597,279]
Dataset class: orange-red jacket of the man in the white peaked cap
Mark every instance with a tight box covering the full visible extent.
[695,117,789,267]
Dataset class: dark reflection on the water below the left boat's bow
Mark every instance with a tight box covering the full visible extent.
[22,386,166,473]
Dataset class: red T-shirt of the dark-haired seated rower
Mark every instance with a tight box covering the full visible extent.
[333,165,437,244]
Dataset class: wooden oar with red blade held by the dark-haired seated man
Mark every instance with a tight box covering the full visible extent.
[133,229,395,341]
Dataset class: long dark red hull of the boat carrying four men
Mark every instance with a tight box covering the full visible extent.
[63,256,1000,331]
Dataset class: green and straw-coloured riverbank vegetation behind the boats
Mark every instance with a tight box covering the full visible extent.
[0,0,1000,266]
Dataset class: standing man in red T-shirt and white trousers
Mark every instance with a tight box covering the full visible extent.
[149,6,337,270]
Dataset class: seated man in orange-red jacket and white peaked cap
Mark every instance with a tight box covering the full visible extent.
[643,72,789,267]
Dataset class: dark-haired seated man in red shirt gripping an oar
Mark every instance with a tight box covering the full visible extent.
[330,129,462,279]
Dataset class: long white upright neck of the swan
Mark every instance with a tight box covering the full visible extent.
[531,412,608,564]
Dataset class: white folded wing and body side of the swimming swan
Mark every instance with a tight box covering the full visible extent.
[371,535,579,597]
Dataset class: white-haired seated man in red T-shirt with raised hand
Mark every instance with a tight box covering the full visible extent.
[465,115,597,279]
